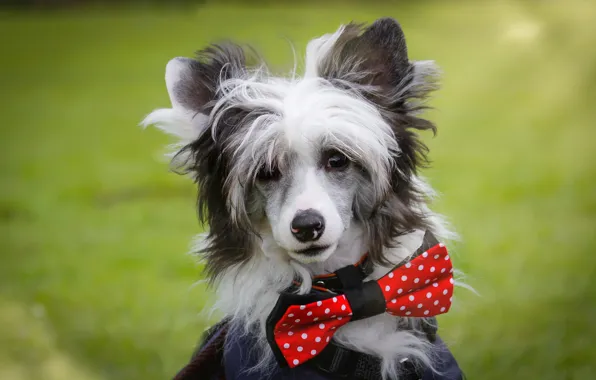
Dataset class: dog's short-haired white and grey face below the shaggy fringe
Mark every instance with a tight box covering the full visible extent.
[255,144,363,262]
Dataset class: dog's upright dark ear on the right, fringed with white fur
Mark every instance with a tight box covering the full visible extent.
[306,18,436,109]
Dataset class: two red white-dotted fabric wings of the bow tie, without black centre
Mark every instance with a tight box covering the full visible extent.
[274,240,454,368]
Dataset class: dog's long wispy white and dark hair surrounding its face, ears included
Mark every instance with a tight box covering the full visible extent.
[143,18,451,374]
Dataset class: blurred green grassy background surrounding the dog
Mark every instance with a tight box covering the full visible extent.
[0,0,596,380]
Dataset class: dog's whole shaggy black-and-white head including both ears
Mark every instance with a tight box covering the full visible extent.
[145,19,435,275]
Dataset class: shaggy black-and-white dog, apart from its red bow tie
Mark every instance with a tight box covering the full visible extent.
[142,18,463,380]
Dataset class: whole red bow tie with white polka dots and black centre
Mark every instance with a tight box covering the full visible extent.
[267,240,454,368]
